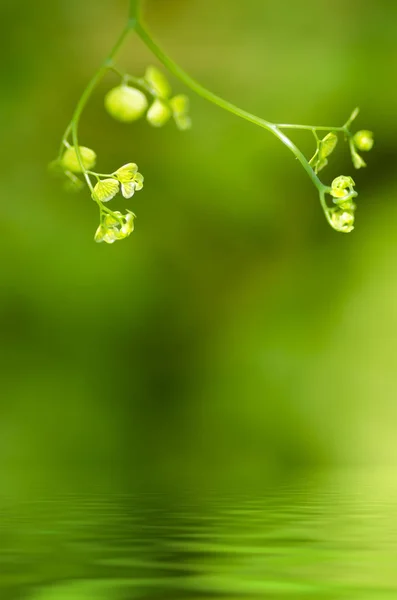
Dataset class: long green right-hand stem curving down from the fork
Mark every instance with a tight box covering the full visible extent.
[136,22,327,190]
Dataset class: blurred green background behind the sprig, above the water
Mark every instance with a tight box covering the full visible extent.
[0,0,397,495]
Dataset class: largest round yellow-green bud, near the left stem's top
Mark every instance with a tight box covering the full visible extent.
[105,84,148,123]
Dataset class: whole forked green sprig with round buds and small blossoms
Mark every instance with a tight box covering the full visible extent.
[51,0,374,244]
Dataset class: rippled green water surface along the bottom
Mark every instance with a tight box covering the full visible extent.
[0,472,397,600]
